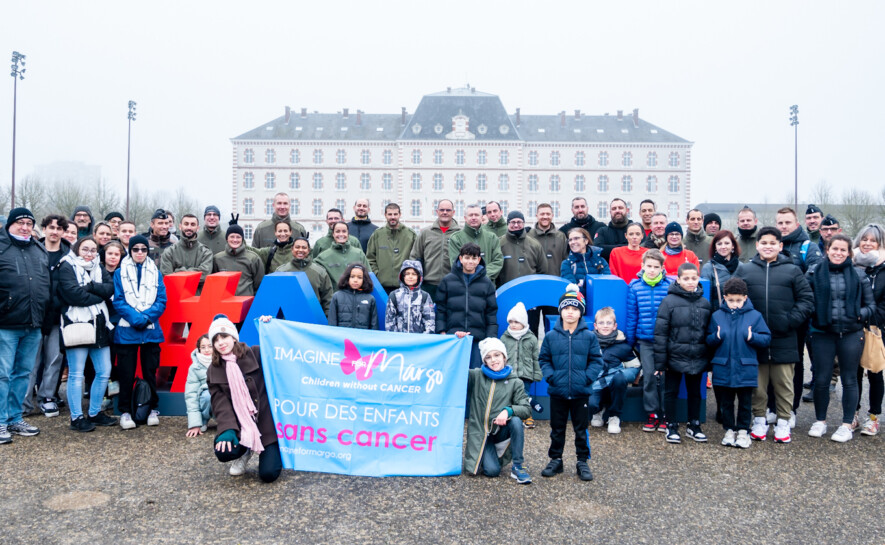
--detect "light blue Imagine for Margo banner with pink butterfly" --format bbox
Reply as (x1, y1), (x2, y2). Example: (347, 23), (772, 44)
(258, 320), (471, 477)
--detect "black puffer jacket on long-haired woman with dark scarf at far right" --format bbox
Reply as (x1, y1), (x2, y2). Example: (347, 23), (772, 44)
(805, 258), (876, 334)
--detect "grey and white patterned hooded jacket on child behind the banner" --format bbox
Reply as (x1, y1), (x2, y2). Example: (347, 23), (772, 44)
(384, 259), (436, 333)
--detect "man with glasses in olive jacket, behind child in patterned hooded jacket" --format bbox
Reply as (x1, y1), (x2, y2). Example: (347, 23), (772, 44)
(409, 199), (461, 302)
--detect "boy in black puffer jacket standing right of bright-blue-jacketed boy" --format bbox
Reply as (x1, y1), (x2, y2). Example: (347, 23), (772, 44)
(655, 263), (712, 443)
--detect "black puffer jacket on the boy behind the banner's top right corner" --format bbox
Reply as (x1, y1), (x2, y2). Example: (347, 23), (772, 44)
(436, 260), (498, 342)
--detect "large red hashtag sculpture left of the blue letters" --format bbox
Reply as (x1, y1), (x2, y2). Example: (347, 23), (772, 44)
(160, 272), (253, 393)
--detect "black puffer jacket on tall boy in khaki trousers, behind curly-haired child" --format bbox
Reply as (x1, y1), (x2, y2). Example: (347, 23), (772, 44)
(735, 254), (814, 364)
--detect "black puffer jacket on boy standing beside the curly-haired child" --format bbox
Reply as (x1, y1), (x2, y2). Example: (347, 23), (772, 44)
(655, 282), (713, 375)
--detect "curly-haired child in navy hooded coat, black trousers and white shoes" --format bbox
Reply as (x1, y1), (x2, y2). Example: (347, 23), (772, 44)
(707, 278), (771, 448)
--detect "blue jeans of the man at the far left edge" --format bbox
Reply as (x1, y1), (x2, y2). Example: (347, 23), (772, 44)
(0, 327), (42, 424)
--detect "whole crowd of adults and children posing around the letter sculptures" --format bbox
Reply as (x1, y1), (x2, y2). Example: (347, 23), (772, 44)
(0, 193), (885, 483)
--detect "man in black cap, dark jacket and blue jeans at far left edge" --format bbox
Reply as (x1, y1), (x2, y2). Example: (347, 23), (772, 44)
(0, 208), (49, 444)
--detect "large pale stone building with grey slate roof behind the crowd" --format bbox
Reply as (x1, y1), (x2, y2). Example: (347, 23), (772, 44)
(231, 88), (693, 237)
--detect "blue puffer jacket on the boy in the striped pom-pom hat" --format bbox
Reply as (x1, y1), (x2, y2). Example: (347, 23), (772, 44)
(538, 318), (602, 399)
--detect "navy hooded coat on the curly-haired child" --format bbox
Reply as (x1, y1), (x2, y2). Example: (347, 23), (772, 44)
(707, 299), (771, 388)
